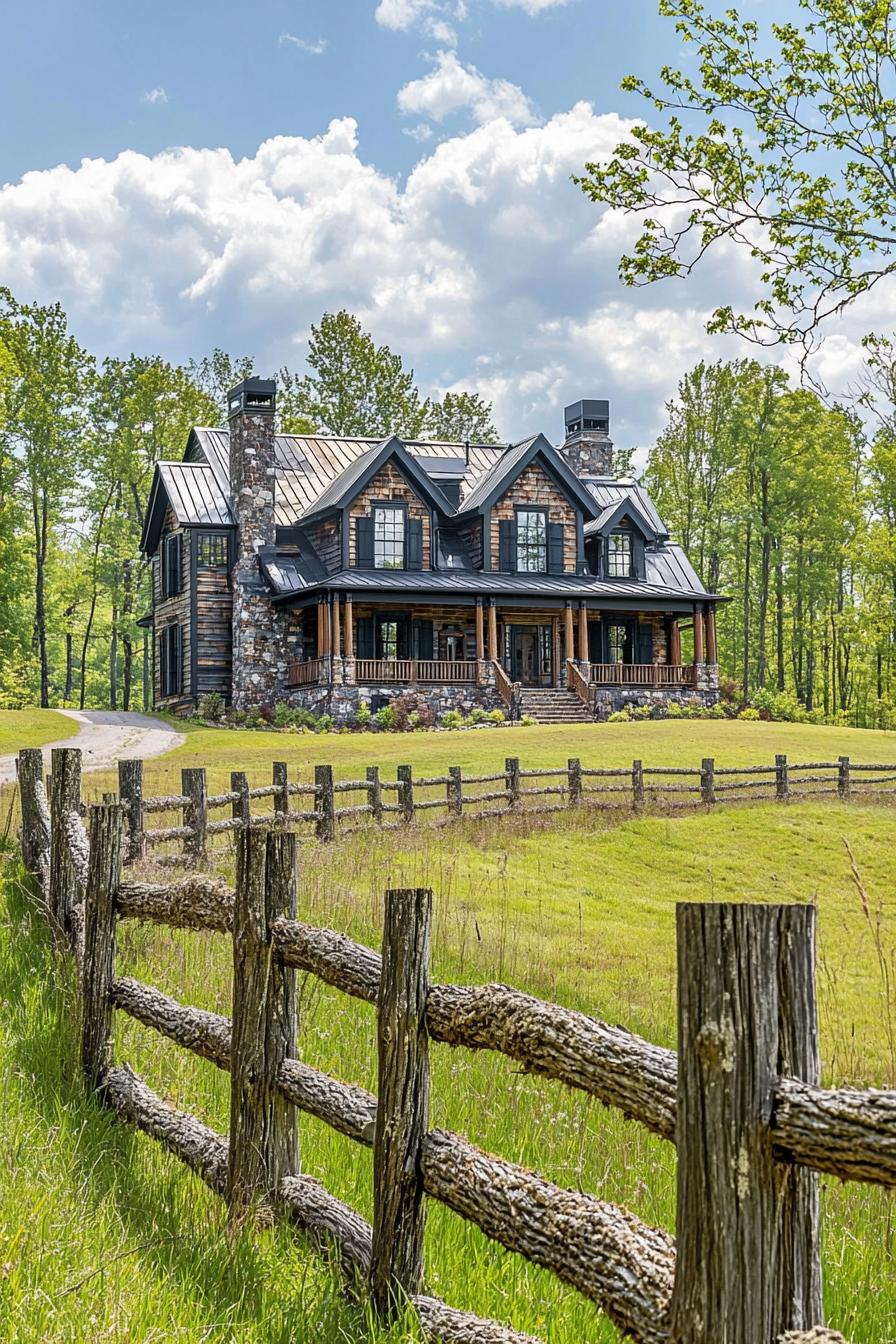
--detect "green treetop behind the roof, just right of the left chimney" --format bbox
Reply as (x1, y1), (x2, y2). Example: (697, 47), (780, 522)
(287, 310), (427, 438)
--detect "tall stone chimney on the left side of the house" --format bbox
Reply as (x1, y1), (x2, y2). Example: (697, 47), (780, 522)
(227, 378), (286, 710)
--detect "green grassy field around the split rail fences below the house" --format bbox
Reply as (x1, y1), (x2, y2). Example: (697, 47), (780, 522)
(0, 723), (896, 1344)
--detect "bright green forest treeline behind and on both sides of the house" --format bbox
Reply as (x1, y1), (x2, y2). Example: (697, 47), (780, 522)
(0, 280), (896, 726)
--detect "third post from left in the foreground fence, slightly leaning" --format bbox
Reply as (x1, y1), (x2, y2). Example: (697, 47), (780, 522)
(81, 802), (122, 1087)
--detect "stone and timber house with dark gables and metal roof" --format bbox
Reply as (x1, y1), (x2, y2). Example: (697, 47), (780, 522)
(141, 379), (723, 722)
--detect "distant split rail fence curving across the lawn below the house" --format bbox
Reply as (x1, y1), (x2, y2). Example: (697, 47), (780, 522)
(15, 749), (896, 866)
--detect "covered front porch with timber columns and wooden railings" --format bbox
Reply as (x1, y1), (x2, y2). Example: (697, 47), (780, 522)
(287, 593), (716, 704)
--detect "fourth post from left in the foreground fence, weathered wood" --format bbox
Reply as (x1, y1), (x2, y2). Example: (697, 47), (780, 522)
(227, 828), (298, 1223)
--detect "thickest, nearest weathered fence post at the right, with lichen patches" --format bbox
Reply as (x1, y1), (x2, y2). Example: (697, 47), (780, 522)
(669, 903), (821, 1344)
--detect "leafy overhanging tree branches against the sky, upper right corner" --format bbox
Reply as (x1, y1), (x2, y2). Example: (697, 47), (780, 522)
(578, 0), (896, 349)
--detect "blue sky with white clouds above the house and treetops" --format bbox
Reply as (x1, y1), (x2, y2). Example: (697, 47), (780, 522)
(0, 0), (860, 448)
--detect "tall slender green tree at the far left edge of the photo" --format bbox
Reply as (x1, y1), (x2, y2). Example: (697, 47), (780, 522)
(0, 289), (93, 708)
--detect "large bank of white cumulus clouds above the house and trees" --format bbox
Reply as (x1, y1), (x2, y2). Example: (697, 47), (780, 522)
(0, 103), (866, 445)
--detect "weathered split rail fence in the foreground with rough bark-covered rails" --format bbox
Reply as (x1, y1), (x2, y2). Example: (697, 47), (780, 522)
(12, 749), (896, 1344)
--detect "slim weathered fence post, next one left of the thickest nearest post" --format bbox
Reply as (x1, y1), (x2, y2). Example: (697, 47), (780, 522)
(369, 887), (433, 1316)
